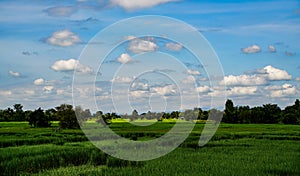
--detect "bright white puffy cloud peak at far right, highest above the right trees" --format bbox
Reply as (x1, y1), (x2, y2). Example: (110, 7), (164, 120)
(264, 65), (292, 80)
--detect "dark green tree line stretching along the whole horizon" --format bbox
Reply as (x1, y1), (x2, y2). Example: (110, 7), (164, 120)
(0, 99), (300, 128)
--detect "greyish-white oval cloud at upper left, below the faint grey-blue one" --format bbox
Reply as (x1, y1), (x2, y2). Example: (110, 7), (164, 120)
(46, 29), (81, 47)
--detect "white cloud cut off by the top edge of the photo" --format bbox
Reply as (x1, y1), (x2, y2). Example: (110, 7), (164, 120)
(110, 0), (178, 10)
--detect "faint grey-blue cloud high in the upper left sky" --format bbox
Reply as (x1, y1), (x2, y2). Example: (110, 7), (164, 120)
(45, 6), (76, 17)
